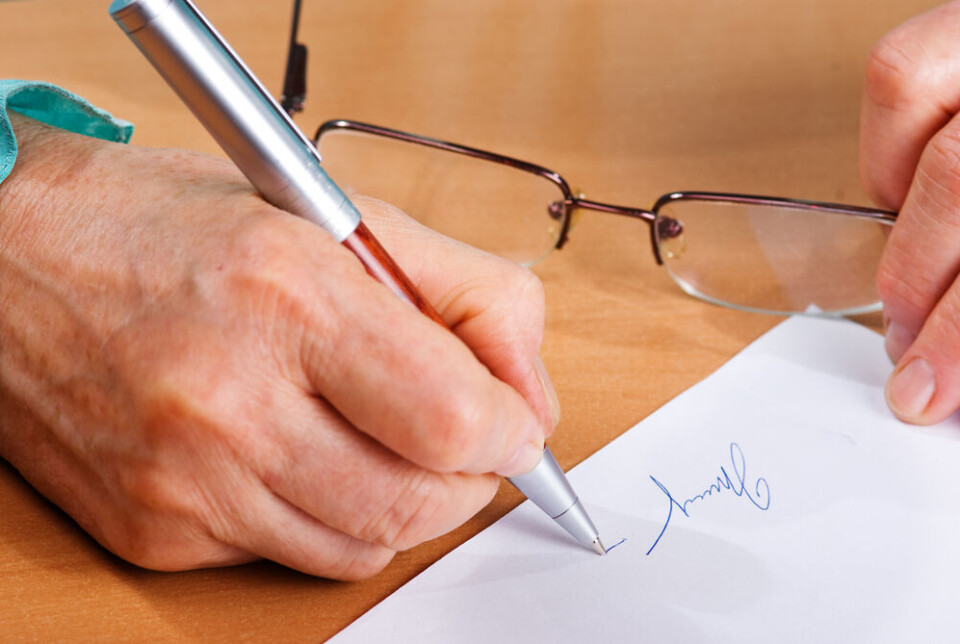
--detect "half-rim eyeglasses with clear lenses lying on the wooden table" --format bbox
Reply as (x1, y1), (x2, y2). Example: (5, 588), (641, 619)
(281, 0), (896, 315)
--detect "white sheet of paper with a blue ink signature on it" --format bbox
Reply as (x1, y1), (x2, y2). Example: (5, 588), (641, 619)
(335, 318), (960, 644)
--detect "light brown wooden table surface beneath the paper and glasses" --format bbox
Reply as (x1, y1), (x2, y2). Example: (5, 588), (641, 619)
(0, 0), (935, 641)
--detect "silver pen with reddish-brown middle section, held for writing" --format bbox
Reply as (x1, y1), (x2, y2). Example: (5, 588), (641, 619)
(110, 0), (605, 555)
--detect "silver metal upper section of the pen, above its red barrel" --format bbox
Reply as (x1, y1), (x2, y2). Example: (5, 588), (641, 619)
(110, 0), (360, 242)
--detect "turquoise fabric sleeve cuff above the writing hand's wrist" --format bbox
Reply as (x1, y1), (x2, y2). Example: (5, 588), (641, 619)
(0, 80), (133, 182)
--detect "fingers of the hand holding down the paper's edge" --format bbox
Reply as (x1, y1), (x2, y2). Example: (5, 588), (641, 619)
(860, 2), (960, 424)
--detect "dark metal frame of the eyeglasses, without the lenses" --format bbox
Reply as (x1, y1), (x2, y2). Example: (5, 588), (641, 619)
(281, 0), (897, 296)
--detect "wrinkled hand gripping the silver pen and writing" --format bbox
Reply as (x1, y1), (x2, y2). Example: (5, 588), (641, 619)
(0, 113), (555, 579)
